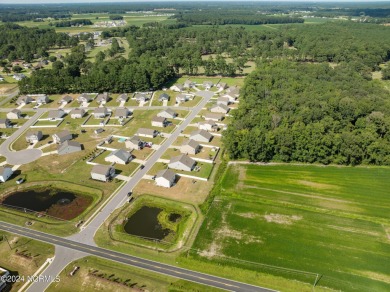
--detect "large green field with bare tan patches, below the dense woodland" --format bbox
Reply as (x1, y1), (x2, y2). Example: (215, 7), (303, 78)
(194, 165), (390, 291)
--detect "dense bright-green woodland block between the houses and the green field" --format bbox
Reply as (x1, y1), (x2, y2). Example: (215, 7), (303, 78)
(224, 61), (390, 165)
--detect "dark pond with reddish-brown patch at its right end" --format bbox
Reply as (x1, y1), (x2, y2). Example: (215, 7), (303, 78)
(1, 189), (92, 220)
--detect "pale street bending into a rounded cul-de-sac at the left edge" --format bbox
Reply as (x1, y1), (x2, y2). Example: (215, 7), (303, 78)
(0, 109), (46, 165)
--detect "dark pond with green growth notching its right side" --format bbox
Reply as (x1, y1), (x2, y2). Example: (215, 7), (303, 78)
(124, 206), (171, 240)
